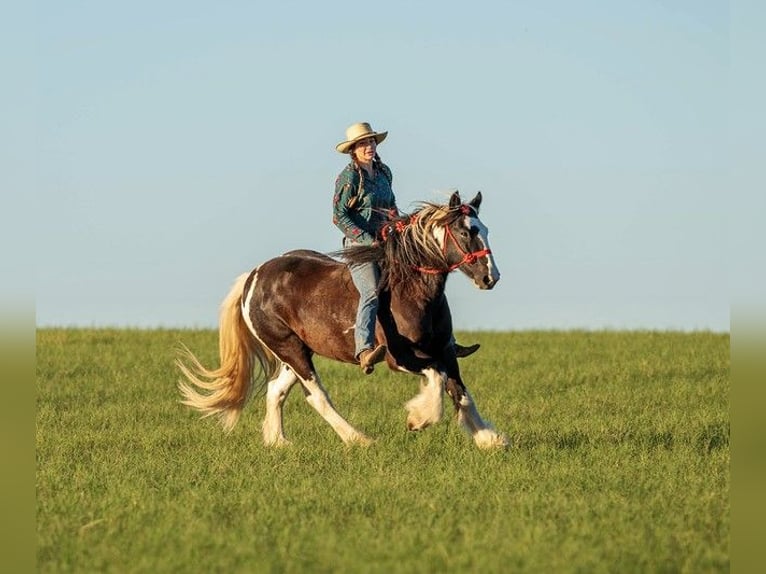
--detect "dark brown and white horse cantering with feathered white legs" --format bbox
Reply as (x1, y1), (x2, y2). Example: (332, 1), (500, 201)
(177, 191), (508, 448)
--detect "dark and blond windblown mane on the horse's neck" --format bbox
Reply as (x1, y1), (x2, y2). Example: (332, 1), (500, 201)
(334, 202), (462, 289)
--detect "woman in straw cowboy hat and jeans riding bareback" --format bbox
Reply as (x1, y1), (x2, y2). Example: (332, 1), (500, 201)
(333, 122), (479, 374)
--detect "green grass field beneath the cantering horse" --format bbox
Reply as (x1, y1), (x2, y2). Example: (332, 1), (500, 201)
(36, 329), (730, 573)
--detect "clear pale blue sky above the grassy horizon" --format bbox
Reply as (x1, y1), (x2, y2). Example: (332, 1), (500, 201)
(13, 0), (756, 331)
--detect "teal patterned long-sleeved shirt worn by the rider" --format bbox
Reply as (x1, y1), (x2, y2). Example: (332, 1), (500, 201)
(332, 163), (398, 245)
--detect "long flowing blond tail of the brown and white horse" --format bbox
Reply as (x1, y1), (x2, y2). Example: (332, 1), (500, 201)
(176, 273), (277, 432)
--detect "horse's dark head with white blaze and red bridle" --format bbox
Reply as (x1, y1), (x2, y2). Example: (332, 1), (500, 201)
(437, 191), (500, 289)
